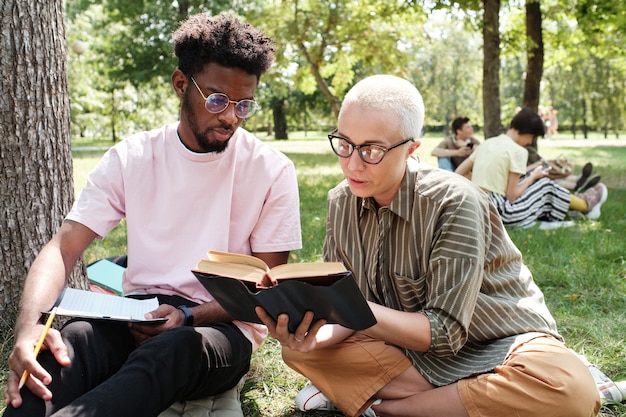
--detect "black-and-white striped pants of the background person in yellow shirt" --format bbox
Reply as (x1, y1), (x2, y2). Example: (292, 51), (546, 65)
(488, 178), (571, 227)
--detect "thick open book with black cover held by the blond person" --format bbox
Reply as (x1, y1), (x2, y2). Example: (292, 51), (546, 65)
(192, 251), (376, 333)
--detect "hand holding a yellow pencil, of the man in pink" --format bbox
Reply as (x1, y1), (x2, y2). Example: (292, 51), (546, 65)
(4, 325), (70, 408)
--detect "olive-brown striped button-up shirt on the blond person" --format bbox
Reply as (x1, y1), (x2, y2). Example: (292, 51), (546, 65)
(324, 159), (561, 386)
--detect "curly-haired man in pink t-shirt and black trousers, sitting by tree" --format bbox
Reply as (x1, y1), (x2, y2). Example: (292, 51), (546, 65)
(4, 14), (301, 417)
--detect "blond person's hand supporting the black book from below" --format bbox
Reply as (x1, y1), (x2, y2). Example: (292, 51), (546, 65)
(255, 307), (326, 352)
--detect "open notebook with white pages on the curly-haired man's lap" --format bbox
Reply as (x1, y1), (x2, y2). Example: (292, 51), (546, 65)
(48, 288), (167, 323)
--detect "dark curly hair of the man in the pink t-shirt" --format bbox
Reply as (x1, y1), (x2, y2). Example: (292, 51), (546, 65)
(172, 13), (274, 79)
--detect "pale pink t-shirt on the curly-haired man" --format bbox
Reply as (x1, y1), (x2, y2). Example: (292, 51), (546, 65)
(67, 123), (302, 348)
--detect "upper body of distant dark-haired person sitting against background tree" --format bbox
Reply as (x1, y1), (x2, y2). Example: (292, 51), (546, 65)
(430, 117), (480, 171)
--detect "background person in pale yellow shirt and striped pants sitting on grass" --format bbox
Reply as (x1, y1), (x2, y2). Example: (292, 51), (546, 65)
(455, 108), (608, 227)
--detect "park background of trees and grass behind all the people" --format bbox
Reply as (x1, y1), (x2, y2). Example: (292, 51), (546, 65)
(0, 0), (626, 417)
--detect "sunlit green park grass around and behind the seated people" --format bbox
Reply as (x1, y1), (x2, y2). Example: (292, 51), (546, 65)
(0, 132), (626, 417)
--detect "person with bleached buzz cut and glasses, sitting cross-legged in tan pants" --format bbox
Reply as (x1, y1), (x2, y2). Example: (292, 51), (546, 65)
(257, 75), (600, 417)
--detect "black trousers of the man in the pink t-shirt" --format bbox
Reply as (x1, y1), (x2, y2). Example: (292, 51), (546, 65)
(4, 297), (252, 417)
